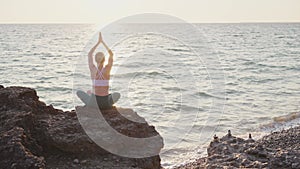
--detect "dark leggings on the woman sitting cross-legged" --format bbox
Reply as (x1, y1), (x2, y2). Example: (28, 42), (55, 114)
(76, 90), (121, 109)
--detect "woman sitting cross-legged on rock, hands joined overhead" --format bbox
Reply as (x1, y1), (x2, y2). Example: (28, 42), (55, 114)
(77, 32), (120, 109)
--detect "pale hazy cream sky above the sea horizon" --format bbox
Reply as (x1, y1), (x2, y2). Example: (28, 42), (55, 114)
(0, 0), (300, 24)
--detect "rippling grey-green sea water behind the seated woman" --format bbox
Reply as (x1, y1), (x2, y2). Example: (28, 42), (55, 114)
(0, 23), (300, 168)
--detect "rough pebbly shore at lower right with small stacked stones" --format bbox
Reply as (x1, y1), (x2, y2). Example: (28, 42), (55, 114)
(176, 126), (300, 169)
